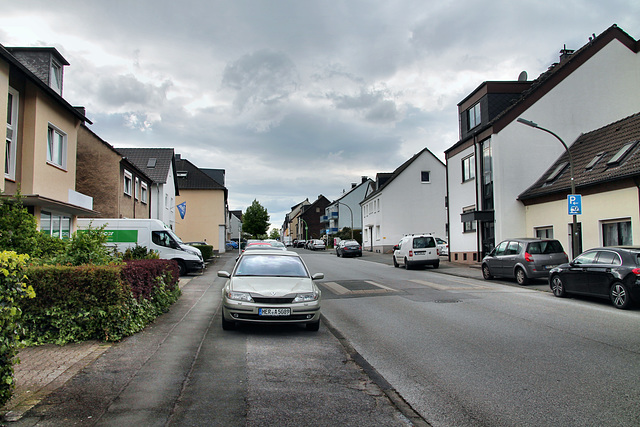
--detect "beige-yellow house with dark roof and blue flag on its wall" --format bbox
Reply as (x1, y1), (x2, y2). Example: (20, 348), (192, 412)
(175, 154), (227, 253)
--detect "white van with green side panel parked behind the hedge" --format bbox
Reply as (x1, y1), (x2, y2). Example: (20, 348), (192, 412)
(78, 218), (204, 276)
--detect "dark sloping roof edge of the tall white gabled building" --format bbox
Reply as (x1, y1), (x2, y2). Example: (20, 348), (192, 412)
(445, 24), (640, 154)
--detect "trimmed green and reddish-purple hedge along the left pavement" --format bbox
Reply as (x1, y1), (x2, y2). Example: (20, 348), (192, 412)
(20, 260), (180, 345)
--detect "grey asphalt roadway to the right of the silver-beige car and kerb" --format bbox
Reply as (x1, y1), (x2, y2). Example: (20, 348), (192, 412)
(302, 252), (640, 426)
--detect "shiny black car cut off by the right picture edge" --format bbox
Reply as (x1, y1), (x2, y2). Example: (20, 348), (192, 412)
(549, 247), (640, 308)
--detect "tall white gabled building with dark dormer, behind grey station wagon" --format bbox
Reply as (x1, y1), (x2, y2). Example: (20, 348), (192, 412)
(445, 25), (640, 263)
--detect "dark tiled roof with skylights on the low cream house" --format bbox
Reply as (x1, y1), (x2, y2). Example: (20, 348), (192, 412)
(518, 113), (640, 200)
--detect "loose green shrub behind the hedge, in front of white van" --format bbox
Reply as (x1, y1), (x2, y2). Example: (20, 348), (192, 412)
(54, 225), (118, 266)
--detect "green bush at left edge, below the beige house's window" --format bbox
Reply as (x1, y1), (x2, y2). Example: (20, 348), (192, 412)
(0, 193), (39, 256)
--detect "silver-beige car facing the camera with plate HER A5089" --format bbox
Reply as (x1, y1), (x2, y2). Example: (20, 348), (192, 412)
(218, 250), (324, 331)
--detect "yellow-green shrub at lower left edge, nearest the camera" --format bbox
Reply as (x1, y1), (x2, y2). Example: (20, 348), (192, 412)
(0, 251), (35, 406)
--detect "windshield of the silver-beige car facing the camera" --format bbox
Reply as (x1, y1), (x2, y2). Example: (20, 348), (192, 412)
(235, 254), (309, 277)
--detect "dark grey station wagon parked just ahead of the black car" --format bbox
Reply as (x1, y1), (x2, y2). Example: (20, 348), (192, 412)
(482, 238), (569, 285)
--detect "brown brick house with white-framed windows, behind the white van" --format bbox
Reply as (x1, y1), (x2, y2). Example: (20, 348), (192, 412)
(76, 124), (153, 218)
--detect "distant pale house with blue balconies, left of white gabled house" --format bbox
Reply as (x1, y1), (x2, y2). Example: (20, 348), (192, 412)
(321, 176), (373, 239)
